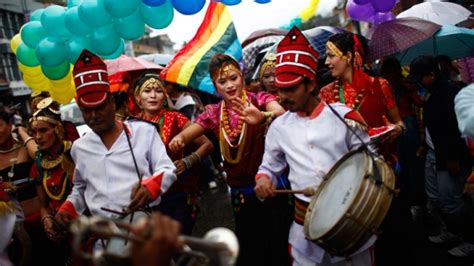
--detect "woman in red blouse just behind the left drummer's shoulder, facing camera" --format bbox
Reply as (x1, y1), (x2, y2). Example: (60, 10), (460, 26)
(135, 74), (213, 234)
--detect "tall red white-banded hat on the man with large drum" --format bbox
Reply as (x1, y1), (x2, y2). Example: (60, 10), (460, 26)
(275, 27), (319, 88)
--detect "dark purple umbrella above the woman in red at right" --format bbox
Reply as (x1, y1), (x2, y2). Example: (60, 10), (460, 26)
(366, 18), (441, 62)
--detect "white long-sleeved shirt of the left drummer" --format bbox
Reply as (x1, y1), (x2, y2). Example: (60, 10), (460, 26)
(67, 121), (176, 218)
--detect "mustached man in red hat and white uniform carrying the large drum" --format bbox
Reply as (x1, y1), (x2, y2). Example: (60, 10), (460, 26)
(255, 28), (375, 265)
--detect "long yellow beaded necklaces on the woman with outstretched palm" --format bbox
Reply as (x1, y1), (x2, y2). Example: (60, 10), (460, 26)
(219, 91), (247, 164)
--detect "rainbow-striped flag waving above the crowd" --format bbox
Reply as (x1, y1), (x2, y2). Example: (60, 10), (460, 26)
(161, 1), (242, 94)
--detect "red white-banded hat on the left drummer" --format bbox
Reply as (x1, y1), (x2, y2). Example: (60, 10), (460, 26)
(72, 50), (109, 108)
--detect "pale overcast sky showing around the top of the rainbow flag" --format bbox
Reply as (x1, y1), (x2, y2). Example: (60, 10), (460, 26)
(152, 0), (337, 48)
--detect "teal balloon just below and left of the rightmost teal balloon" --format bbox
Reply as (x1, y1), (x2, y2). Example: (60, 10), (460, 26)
(115, 9), (145, 40)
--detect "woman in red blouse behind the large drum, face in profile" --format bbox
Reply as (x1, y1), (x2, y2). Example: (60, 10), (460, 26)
(319, 32), (405, 145)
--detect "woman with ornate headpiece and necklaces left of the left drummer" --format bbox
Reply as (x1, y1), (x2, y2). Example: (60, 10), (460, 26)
(30, 97), (75, 263)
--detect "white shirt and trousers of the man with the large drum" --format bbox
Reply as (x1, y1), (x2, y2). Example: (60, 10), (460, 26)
(258, 102), (376, 263)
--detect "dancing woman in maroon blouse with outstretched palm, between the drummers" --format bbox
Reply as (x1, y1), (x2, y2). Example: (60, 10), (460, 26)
(169, 54), (288, 265)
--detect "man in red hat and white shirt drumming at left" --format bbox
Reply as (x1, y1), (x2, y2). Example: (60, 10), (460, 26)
(55, 50), (176, 251)
